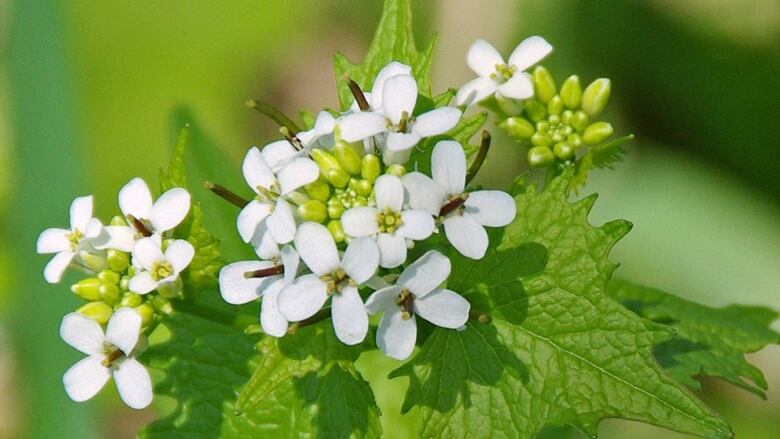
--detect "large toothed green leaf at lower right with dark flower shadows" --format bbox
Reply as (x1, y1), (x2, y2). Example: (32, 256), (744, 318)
(392, 170), (732, 438)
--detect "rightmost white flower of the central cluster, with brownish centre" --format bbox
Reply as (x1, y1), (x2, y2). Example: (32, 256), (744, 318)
(402, 140), (517, 259)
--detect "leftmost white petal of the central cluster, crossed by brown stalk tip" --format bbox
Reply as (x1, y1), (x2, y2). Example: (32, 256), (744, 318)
(219, 261), (279, 305)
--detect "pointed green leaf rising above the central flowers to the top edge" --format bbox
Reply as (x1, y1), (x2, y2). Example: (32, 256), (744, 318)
(333, 0), (436, 110)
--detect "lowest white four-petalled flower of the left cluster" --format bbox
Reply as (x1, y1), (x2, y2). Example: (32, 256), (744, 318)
(60, 308), (152, 409)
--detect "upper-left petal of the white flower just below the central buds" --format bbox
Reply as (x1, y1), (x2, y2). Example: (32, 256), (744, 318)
(295, 222), (339, 276)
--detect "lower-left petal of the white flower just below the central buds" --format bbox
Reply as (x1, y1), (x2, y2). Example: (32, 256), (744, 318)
(276, 274), (328, 322)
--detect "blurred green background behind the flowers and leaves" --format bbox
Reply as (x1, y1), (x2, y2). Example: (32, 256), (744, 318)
(0, 0), (780, 439)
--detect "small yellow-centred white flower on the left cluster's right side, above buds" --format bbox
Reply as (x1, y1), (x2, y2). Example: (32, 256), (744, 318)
(128, 238), (195, 294)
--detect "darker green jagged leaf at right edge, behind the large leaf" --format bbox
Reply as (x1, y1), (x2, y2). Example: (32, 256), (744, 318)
(609, 280), (780, 399)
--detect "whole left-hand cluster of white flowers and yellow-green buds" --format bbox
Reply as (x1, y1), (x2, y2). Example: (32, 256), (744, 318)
(37, 178), (195, 408)
